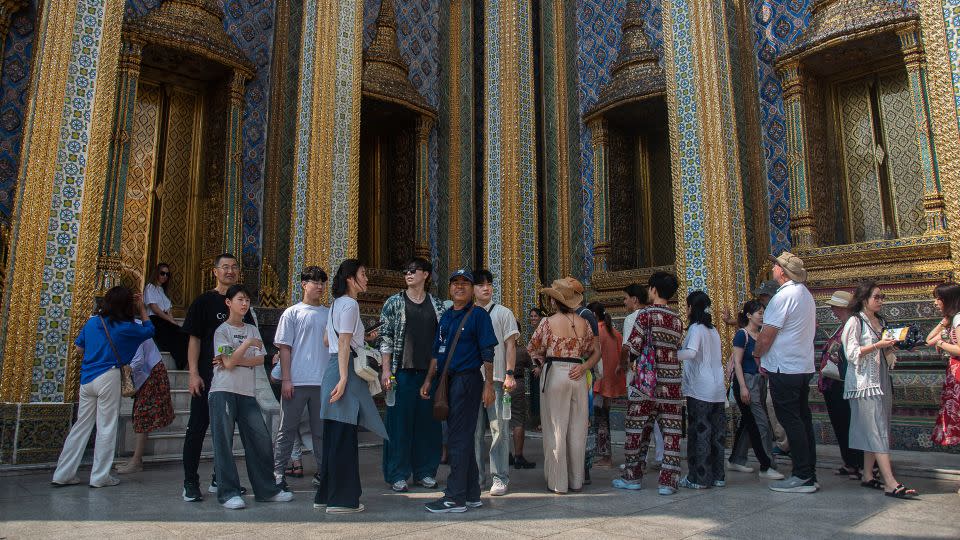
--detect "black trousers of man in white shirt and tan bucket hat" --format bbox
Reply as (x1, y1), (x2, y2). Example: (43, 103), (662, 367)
(768, 373), (817, 480)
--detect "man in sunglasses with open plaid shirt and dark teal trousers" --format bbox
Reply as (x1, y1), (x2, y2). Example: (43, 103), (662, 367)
(380, 257), (444, 492)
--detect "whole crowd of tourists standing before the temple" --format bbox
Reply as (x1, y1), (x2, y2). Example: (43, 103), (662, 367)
(53, 252), (960, 514)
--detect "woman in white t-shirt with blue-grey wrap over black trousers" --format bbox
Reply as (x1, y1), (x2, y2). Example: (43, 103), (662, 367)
(313, 259), (387, 514)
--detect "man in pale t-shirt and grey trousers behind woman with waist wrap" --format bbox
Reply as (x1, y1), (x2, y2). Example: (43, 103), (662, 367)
(273, 266), (330, 491)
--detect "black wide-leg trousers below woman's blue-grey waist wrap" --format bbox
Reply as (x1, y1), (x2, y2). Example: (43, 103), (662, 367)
(313, 420), (361, 508)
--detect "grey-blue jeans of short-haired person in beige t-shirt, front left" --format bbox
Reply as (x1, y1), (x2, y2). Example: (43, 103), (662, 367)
(207, 392), (280, 503)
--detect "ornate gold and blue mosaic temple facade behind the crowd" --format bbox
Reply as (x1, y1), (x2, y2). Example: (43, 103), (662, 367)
(0, 0), (960, 464)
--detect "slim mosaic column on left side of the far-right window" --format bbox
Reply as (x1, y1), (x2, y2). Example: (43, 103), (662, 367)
(780, 62), (817, 247)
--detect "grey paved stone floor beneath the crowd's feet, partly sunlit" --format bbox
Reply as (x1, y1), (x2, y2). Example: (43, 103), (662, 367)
(0, 440), (960, 540)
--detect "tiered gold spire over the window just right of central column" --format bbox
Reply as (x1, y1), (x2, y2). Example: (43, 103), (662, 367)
(587, 0), (667, 121)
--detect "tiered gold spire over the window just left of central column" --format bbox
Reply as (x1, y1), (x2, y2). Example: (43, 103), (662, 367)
(363, 0), (437, 118)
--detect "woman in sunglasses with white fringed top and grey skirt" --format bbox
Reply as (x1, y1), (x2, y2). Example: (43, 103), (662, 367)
(841, 280), (917, 499)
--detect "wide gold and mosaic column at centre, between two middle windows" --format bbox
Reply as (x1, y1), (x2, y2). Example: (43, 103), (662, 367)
(483, 0), (538, 314)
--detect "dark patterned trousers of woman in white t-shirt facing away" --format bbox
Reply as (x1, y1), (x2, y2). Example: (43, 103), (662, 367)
(687, 397), (727, 487)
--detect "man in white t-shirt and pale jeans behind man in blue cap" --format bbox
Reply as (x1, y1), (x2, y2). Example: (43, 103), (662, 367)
(473, 270), (520, 495)
